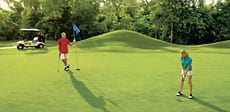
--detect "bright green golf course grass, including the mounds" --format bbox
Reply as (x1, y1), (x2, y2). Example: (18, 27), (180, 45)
(0, 31), (230, 112)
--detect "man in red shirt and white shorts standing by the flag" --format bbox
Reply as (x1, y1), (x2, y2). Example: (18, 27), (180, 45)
(57, 32), (73, 71)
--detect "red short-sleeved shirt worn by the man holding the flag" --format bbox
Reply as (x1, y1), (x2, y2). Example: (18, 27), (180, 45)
(57, 38), (70, 54)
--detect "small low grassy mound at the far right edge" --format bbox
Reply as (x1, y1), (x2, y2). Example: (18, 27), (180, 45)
(203, 40), (230, 48)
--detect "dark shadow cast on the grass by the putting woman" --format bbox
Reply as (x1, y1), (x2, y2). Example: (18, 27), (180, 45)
(192, 97), (226, 112)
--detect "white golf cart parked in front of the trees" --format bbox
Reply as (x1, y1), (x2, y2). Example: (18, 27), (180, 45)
(17, 29), (45, 50)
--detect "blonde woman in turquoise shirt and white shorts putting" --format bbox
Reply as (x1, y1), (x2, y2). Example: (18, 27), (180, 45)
(176, 50), (192, 99)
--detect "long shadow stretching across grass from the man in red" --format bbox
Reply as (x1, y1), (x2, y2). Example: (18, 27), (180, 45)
(67, 71), (110, 112)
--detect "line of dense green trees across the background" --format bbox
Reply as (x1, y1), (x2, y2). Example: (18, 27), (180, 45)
(0, 0), (230, 44)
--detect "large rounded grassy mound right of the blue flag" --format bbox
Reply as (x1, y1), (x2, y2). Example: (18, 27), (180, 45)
(78, 30), (173, 49)
